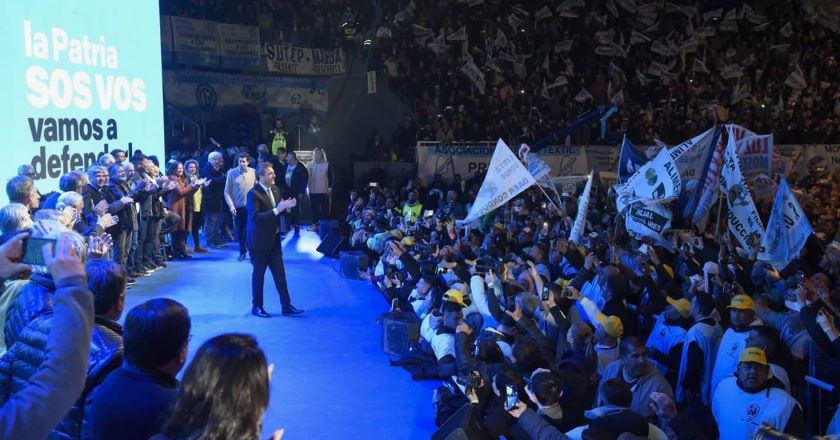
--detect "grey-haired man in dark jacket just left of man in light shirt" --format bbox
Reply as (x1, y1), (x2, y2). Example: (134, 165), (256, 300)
(199, 151), (228, 248)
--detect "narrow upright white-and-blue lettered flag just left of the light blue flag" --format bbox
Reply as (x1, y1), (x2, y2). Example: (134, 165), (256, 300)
(721, 126), (764, 250)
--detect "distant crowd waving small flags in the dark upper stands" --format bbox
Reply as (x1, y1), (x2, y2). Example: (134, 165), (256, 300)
(360, 0), (840, 160)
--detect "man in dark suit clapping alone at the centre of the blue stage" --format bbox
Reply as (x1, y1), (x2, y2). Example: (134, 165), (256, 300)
(245, 163), (303, 318)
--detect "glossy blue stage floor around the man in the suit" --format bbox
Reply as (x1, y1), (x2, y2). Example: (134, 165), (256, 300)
(126, 232), (438, 440)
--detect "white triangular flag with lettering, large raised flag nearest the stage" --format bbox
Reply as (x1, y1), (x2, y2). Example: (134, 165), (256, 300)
(459, 139), (536, 224)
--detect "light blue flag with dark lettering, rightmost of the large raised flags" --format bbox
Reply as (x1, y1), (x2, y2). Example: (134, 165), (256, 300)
(758, 179), (814, 270)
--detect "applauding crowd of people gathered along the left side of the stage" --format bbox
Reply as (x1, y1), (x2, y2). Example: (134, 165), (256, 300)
(0, 145), (333, 440)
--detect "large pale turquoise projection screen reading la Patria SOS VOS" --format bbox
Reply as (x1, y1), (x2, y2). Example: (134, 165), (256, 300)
(0, 0), (164, 200)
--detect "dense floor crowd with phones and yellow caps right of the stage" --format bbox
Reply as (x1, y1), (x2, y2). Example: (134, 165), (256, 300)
(344, 150), (840, 439)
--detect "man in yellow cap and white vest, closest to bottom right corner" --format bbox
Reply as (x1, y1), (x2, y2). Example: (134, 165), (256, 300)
(712, 347), (805, 439)
